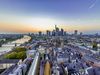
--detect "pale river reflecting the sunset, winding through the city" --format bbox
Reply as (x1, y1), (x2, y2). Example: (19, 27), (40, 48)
(0, 35), (31, 55)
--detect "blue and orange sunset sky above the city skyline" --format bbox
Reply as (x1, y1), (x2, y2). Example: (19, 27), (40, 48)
(0, 0), (100, 33)
